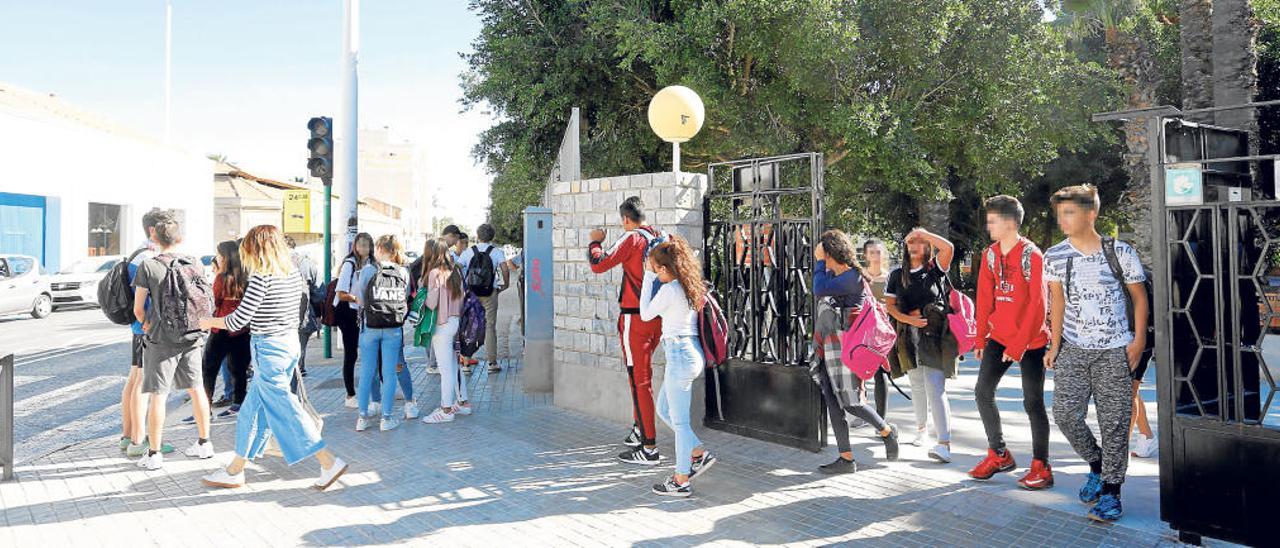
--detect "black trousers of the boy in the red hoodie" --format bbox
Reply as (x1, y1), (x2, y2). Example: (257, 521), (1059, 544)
(974, 341), (1048, 462)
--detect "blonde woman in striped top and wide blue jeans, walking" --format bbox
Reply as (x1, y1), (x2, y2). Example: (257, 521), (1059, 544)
(200, 224), (347, 490)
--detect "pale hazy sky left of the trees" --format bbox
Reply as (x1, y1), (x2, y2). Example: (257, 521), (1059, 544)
(0, 0), (492, 227)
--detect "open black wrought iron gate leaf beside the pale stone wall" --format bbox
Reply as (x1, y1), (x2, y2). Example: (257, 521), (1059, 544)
(703, 154), (827, 451)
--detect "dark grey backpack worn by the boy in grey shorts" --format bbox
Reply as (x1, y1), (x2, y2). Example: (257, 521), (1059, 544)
(147, 254), (214, 344)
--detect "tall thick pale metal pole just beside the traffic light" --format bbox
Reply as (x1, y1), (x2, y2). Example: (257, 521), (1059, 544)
(334, 0), (360, 248)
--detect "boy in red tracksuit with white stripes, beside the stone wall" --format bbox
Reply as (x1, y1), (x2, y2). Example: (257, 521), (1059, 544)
(588, 196), (662, 465)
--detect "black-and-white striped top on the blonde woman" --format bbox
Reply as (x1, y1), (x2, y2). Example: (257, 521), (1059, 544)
(227, 271), (307, 335)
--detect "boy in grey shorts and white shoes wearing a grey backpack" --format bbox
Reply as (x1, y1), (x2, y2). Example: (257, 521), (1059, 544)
(133, 210), (214, 470)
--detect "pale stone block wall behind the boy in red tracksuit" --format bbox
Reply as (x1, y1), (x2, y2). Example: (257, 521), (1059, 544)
(549, 173), (707, 432)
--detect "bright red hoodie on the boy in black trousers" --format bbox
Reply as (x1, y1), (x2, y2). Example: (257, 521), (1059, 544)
(974, 238), (1050, 361)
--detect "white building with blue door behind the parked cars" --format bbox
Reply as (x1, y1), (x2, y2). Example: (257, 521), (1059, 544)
(0, 83), (214, 270)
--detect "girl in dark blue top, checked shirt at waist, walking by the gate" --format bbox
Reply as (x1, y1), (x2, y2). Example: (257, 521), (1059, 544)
(809, 230), (899, 474)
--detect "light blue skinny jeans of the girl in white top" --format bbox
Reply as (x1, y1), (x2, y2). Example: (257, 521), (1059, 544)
(658, 335), (705, 475)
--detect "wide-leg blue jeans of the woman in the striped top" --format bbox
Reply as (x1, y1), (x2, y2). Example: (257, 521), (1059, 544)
(236, 332), (325, 465)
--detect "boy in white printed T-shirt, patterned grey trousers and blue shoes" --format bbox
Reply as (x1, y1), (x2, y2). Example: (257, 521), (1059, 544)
(1044, 184), (1148, 521)
